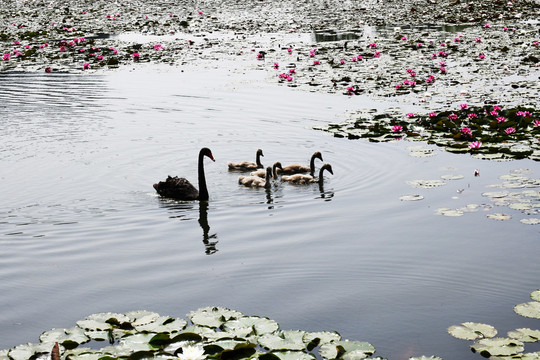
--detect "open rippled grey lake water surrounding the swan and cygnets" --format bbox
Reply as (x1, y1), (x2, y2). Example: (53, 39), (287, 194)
(0, 65), (540, 359)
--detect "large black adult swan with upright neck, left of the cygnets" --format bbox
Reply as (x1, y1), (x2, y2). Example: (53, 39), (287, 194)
(154, 148), (216, 200)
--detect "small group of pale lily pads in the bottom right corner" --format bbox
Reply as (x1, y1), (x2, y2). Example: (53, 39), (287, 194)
(448, 290), (540, 360)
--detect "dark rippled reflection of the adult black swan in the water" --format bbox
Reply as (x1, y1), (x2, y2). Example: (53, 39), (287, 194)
(159, 198), (218, 255)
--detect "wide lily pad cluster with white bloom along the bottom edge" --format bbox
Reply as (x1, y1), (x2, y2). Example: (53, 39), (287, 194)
(0, 307), (388, 360)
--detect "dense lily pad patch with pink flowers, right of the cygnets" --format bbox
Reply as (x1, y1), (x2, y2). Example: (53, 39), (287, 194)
(317, 104), (540, 160)
